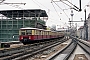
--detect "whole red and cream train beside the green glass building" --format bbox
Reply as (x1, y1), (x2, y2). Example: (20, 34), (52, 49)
(19, 27), (64, 44)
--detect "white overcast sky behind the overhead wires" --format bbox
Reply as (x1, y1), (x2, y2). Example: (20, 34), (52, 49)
(0, 0), (90, 27)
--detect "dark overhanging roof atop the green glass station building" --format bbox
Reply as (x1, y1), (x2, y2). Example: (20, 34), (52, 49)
(0, 9), (48, 18)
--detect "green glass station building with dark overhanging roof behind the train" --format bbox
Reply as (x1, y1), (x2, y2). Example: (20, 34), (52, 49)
(0, 9), (48, 42)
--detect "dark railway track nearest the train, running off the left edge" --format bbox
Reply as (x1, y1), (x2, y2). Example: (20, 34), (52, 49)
(0, 41), (60, 58)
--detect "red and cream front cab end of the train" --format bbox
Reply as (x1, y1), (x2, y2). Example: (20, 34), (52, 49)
(19, 27), (37, 44)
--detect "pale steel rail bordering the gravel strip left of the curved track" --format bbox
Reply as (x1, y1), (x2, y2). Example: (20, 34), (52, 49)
(11, 38), (64, 60)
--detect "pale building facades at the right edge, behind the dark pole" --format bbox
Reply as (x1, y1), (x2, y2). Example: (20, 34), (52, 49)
(77, 14), (90, 40)
